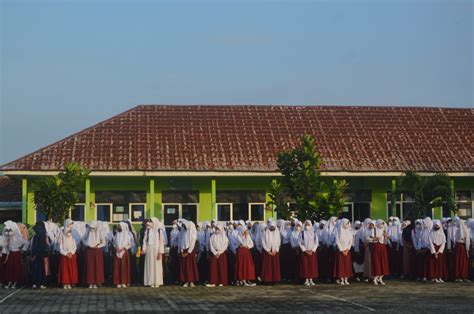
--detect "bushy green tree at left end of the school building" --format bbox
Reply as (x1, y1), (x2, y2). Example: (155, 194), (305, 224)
(34, 163), (90, 222)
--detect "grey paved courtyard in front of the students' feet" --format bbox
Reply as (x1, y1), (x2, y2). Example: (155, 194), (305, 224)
(0, 280), (474, 313)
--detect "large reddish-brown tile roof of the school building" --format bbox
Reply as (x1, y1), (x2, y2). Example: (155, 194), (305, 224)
(1, 105), (474, 172)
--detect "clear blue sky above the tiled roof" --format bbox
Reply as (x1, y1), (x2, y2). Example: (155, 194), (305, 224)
(0, 0), (474, 163)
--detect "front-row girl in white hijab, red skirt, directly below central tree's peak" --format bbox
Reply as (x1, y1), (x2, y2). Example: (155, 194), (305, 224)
(298, 220), (319, 286)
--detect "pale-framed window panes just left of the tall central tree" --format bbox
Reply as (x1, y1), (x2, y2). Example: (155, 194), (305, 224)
(217, 203), (265, 221)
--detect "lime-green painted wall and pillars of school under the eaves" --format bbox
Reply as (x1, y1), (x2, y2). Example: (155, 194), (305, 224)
(22, 177), (474, 224)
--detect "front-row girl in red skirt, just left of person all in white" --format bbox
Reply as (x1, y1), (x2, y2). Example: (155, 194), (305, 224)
(113, 222), (132, 288)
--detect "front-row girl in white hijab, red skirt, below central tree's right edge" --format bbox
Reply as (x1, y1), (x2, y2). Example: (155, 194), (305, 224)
(333, 218), (354, 285)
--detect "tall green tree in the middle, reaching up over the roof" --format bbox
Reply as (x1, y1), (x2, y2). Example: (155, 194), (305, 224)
(270, 135), (348, 220)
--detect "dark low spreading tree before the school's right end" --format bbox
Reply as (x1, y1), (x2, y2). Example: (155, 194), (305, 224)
(397, 171), (456, 219)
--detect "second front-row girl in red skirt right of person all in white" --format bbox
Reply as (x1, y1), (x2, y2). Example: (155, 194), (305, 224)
(206, 224), (229, 287)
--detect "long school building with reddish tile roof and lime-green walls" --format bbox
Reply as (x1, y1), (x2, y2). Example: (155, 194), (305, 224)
(0, 105), (474, 226)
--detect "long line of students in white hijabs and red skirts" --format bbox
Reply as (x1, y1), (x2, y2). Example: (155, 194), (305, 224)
(0, 217), (474, 289)
